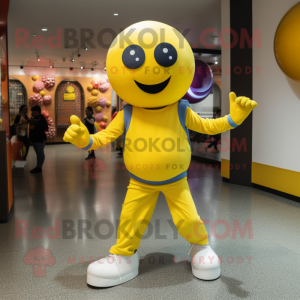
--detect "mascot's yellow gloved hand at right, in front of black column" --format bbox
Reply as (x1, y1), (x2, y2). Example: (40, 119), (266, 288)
(228, 92), (257, 127)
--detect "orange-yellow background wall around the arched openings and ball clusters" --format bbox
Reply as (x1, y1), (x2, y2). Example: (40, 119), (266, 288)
(12, 75), (112, 143)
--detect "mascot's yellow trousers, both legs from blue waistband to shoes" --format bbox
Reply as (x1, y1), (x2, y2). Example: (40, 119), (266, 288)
(110, 178), (208, 256)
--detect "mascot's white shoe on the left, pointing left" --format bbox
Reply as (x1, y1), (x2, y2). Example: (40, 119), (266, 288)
(87, 252), (139, 287)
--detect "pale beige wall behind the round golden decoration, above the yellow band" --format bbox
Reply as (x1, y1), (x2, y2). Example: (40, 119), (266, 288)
(253, 0), (300, 172)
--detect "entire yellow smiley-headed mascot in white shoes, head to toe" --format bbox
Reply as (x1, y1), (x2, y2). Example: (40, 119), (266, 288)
(64, 21), (257, 287)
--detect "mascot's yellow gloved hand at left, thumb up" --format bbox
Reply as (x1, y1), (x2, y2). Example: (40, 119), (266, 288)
(63, 115), (92, 150)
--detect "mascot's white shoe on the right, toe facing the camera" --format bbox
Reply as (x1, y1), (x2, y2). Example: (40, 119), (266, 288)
(190, 244), (221, 280)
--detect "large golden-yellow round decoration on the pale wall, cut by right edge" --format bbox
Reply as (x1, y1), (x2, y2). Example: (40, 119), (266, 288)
(274, 2), (300, 83)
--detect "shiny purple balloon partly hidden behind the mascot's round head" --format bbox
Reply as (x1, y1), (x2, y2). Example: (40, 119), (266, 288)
(182, 60), (213, 103)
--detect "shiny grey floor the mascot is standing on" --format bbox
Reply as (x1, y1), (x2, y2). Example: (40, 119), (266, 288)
(0, 145), (300, 300)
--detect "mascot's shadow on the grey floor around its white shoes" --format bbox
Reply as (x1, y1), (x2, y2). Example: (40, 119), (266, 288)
(55, 253), (245, 298)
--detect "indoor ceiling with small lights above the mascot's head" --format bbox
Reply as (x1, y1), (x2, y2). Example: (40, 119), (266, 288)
(8, 0), (221, 70)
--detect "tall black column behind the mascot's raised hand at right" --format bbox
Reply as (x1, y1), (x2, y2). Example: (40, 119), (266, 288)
(230, 0), (253, 186)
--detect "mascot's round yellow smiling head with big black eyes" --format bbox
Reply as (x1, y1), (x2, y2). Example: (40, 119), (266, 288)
(106, 21), (195, 108)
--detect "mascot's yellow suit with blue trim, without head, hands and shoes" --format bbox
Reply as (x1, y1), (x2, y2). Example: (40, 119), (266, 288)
(89, 100), (233, 256)
